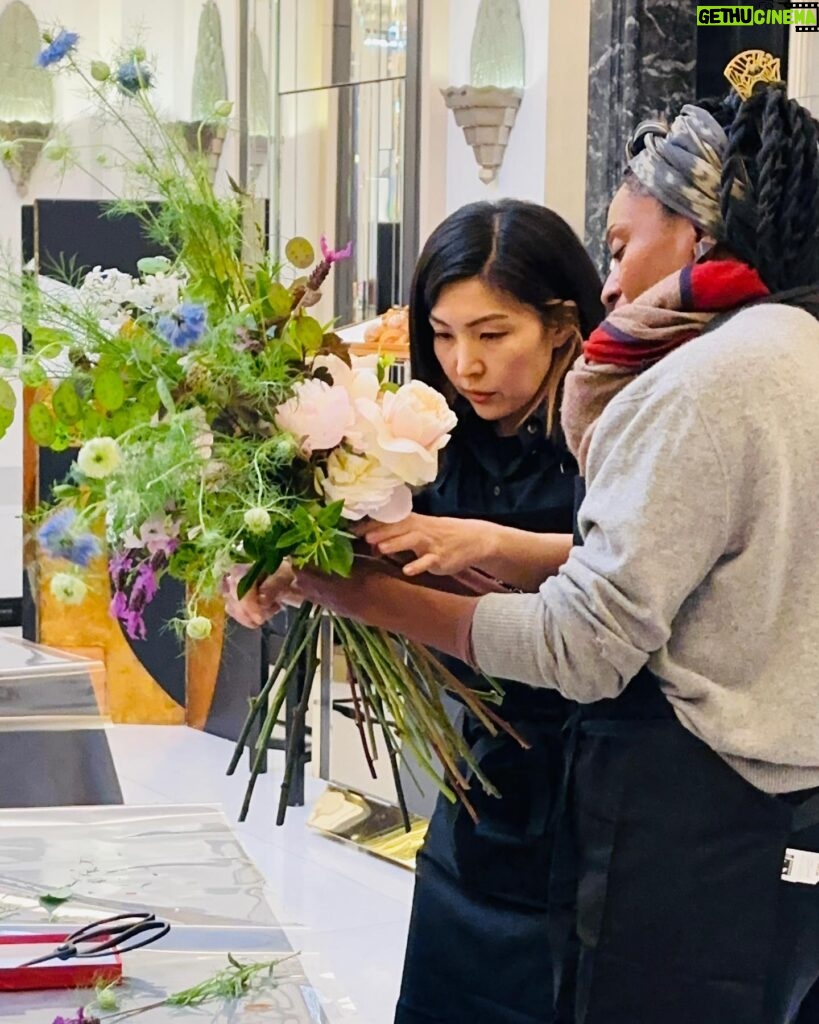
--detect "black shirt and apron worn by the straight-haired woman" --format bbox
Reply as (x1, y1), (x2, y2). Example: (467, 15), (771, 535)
(395, 407), (574, 1024)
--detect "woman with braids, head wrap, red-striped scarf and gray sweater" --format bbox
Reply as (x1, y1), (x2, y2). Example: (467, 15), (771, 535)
(288, 67), (819, 1024)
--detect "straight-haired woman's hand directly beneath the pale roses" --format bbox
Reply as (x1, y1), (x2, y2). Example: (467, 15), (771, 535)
(356, 512), (495, 577)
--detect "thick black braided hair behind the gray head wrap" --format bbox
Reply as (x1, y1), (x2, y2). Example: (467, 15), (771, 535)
(716, 83), (819, 292)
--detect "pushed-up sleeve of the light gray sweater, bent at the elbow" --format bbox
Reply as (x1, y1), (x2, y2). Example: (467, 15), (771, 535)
(471, 382), (730, 702)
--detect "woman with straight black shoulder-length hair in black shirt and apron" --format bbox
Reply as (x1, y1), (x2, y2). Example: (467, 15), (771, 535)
(384, 200), (603, 1024)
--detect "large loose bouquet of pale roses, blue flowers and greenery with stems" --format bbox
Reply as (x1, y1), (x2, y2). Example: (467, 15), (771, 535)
(0, 31), (518, 820)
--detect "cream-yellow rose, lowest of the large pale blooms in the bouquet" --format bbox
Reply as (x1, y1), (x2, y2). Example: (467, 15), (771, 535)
(315, 449), (413, 522)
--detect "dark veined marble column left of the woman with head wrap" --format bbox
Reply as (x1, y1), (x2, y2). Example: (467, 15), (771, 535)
(586, 0), (696, 273)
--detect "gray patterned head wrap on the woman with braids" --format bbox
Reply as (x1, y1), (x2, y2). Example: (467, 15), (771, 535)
(629, 103), (743, 240)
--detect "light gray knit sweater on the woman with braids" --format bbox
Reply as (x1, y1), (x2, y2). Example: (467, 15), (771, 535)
(472, 305), (819, 793)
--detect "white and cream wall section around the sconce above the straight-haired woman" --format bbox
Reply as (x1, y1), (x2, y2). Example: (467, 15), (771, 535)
(420, 0), (591, 242)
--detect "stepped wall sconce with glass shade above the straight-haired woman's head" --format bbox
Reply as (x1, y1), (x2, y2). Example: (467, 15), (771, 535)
(441, 0), (525, 184)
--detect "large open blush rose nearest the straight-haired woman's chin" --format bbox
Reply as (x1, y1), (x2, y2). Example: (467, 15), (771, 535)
(355, 381), (458, 486)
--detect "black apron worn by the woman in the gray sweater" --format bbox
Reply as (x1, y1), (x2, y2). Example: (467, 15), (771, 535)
(550, 483), (819, 1024)
